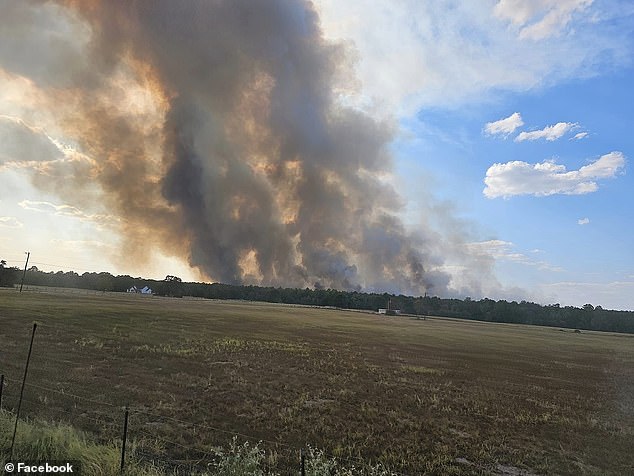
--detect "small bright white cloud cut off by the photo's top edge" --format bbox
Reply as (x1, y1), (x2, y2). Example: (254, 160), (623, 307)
(493, 0), (593, 40)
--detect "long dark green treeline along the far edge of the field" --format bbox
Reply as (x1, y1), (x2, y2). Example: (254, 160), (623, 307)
(6, 267), (634, 333)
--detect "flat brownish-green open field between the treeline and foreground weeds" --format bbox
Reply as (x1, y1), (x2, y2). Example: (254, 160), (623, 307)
(0, 290), (634, 475)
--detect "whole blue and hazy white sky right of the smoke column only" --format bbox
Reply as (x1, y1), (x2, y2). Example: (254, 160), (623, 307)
(316, 0), (634, 309)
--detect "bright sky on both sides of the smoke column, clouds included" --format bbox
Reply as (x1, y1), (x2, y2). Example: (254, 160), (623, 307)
(0, 0), (634, 310)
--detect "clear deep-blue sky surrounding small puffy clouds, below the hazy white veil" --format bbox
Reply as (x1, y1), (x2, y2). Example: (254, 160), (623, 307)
(394, 69), (634, 305)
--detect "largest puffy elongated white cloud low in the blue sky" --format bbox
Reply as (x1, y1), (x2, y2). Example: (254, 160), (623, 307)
(483, 152), (625, 198)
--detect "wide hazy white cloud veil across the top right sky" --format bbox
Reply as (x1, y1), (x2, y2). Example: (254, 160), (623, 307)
(315, 0), (632, 115)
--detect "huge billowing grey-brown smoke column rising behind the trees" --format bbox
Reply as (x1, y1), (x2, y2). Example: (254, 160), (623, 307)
(4, 0), (449, 294)
